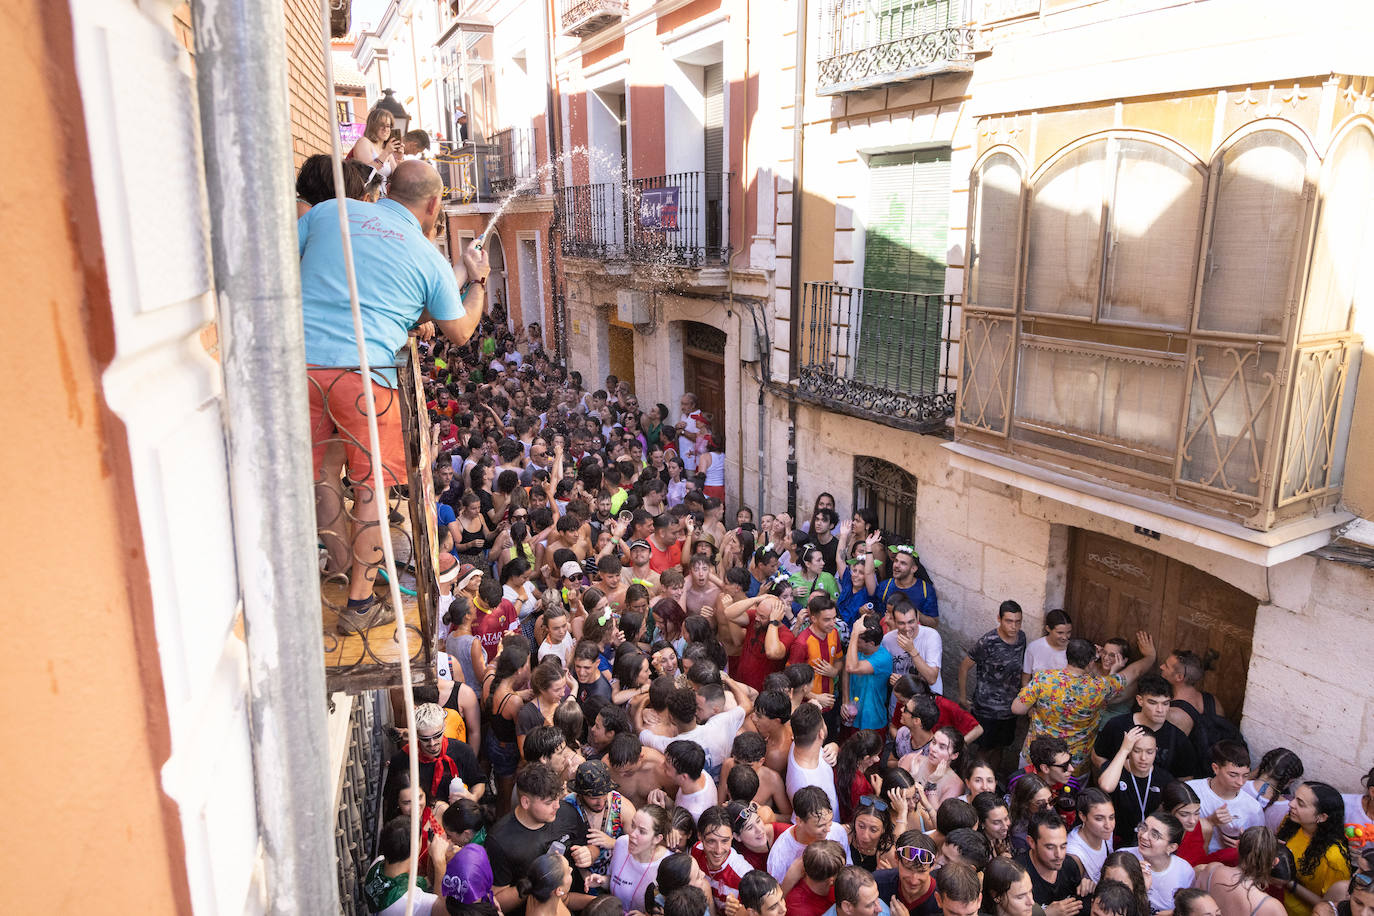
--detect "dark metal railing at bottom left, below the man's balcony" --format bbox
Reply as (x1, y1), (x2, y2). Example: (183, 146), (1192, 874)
(330, 691), (390, 916)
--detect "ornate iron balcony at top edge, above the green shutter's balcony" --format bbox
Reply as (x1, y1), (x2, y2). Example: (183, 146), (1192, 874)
(816, 0), (973, 95)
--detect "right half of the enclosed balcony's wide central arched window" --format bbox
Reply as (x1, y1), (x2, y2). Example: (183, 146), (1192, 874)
(1102, 140), (1205, 330)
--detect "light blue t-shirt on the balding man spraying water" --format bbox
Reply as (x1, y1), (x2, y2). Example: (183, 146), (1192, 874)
(295, 201), (463, 383)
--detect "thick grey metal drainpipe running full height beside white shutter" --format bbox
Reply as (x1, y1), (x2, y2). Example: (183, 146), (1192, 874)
(191, 0), (339, 913)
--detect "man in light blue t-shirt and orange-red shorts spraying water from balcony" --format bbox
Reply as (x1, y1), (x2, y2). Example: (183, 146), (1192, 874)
(297, 161), (491, 634)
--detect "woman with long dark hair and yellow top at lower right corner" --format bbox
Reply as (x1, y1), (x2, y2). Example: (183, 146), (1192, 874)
(1278, 783), (1353, 916)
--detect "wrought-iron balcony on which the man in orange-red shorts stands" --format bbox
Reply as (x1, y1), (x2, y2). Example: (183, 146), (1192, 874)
(312, 341), (438, 694)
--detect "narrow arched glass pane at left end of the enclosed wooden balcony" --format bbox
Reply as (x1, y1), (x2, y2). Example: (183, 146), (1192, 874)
(969, 152), (1021, 309)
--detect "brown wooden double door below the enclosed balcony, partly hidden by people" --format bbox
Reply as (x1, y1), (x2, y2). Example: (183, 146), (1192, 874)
(1066, 530), (1259, 721)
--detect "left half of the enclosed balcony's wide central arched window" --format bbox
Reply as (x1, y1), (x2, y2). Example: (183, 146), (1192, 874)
(1026, 140), (1107, 317)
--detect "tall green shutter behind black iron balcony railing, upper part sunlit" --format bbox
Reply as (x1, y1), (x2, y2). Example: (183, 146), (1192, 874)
(855, 148), (949, 393)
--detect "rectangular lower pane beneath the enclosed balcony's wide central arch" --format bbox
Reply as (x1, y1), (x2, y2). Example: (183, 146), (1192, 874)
(1015, 341), (1184, 456)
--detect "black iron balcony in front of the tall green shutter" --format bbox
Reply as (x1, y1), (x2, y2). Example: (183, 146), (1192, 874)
(798, 283), (959, 433)
